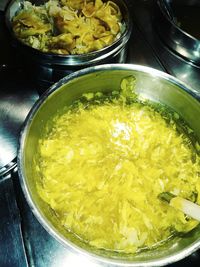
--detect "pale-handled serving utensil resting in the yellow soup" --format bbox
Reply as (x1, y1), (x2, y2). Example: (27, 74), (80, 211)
(158, 192), (200, 221)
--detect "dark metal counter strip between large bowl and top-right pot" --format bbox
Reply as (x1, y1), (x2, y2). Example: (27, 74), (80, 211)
(132, 0), (200, 92)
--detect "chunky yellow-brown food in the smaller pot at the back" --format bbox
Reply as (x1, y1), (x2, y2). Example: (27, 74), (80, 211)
(12, 0), (125, 55)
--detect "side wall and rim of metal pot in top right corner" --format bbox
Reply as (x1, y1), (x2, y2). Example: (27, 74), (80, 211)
(155, 0), (200, 64)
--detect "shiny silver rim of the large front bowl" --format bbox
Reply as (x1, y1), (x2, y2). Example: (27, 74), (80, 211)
(17, 64), (200, 267)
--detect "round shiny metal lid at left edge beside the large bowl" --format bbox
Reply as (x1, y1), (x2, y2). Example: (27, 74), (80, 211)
(0, 65), (38, 176)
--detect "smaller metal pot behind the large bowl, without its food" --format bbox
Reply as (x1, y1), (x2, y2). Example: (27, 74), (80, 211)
(5, 0), (132, 84)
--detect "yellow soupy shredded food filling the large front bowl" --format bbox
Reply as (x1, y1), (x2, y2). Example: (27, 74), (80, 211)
(35, 77), (200, 253)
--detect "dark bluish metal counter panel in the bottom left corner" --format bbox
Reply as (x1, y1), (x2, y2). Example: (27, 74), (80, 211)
(0, 176), (27, 267)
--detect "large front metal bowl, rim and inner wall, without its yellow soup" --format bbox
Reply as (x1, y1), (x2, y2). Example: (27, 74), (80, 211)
(18, 64), (200, 266)
